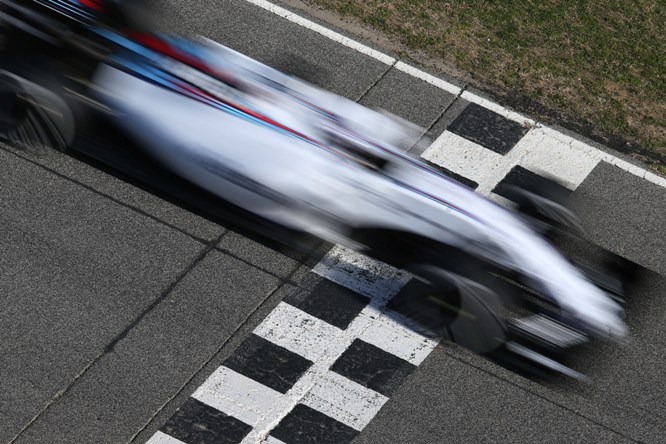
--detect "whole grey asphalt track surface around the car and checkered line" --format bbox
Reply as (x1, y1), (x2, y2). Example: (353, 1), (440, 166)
(0, 0), (666, 443)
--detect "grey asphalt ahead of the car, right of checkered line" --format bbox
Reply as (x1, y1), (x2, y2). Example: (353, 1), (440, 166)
(355, 163), (666, 443)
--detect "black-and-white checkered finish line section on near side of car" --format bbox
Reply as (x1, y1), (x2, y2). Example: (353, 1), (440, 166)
(149, 247), (437, 444)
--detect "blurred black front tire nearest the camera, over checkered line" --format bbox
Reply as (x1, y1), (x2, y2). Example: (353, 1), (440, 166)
(392, 264), (512, 354)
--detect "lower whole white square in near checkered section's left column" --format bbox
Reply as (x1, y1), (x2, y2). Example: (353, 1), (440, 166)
(192, 366), (286, 426)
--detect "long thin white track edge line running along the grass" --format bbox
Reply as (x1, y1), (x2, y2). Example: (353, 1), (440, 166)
(245, 0), (666, 189)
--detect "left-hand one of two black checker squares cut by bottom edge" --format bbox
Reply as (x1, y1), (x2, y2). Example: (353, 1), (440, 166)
(160, 398), (252, 444)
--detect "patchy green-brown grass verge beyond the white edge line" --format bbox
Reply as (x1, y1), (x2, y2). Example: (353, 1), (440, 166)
(305, 0), (666, 168)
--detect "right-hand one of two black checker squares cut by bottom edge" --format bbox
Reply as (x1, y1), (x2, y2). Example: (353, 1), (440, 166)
(271, 404), (359, 444)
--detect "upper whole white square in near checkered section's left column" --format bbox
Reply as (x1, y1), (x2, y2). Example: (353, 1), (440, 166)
(254, 302), (342, 361)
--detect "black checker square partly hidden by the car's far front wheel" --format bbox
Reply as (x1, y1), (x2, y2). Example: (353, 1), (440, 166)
(493, 165), (573, 202)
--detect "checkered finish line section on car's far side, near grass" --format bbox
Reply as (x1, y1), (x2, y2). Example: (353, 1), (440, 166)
(421, 103), (604, 201)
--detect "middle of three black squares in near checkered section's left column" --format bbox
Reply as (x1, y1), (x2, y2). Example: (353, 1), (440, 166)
(224, 334), (312, 393)
